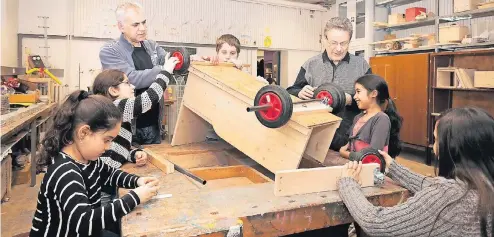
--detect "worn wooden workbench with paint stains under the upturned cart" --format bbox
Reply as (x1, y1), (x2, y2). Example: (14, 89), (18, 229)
(120, 142), (408, 237)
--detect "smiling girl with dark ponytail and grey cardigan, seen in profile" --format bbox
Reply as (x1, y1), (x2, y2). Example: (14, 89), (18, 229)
(340, 74), (403, 158)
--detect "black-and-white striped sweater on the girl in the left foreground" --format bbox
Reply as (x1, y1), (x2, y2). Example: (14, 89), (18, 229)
(30, 152), (140, 237)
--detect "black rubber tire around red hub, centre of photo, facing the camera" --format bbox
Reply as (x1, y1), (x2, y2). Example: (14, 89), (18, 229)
(254, 85), (293, 128)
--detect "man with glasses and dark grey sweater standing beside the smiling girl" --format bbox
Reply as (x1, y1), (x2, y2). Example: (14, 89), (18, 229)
(287, 17), (372, 154)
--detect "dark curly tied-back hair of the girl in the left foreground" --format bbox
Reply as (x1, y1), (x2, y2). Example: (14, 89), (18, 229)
(41, 90), (122, 164)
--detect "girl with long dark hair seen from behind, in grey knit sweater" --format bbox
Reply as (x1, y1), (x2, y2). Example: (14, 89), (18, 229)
(338, 108), (494, 237)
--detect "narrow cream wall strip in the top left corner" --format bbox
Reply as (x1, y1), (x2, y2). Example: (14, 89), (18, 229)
(0, 0), (19, 67)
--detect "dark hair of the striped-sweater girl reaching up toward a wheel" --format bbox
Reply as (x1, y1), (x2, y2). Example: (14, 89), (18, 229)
(93, 69), (125, 100)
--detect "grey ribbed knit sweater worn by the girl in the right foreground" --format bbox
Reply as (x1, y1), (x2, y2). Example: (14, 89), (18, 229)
(338, 162), (492, 237)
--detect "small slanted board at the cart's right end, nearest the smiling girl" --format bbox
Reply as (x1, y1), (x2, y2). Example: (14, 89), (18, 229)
(304, 121), (340, 162)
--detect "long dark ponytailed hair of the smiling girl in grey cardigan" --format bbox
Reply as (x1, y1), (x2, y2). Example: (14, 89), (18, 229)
(355, 74), (403, 157)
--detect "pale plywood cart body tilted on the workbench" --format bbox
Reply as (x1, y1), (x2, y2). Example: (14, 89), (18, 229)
(171, 65), (341, 172)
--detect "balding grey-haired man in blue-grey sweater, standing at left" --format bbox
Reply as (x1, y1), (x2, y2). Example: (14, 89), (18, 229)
(99, 3), (166, 144)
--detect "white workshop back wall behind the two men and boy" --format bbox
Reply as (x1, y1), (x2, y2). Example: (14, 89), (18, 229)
(18, 0), (329, 90)
